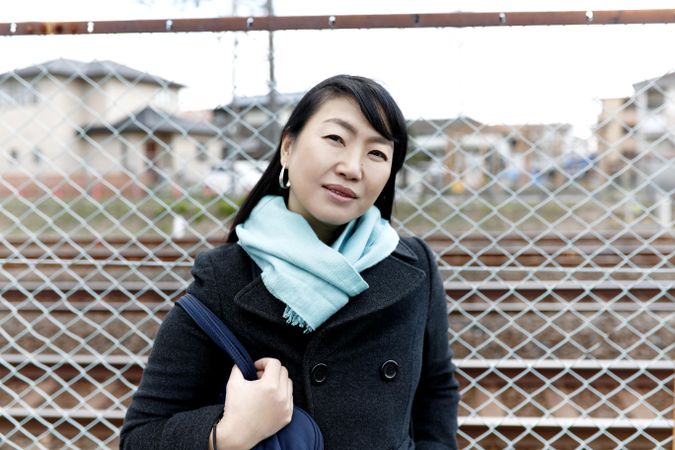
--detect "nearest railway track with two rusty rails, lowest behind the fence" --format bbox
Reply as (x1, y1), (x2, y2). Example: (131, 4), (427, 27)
(0, 354), (674, 448)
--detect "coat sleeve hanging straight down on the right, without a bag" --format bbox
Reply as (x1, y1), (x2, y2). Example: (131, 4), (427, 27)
(412, 239), (459, 450)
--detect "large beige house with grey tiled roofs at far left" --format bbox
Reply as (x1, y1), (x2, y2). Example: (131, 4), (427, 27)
(0, 59), (219, 196)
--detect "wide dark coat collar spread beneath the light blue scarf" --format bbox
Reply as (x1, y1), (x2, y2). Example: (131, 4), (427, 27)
(234, 240), (426, 332)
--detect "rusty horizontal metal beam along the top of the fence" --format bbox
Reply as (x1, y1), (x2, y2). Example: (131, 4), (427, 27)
(0, 9), (675, 36)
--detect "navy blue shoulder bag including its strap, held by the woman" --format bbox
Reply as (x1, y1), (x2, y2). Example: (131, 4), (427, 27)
(177, 294), (323, 450)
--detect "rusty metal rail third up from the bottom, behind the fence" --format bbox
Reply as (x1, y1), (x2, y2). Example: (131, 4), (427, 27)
(0, 280), (675, 312)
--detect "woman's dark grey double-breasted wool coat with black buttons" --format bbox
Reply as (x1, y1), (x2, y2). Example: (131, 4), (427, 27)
(121, 238), (459, 450)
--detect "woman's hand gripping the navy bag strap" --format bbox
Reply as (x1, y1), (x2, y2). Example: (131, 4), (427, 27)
(217, 358), (293, 450)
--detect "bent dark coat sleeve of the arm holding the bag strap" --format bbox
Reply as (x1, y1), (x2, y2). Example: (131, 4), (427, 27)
(120, 254), (232, 450)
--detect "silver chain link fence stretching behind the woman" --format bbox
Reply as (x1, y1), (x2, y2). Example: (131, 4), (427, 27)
(0, 14), (675, 450)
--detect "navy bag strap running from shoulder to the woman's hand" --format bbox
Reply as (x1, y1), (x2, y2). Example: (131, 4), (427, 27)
(176, 294), (258, 381)
